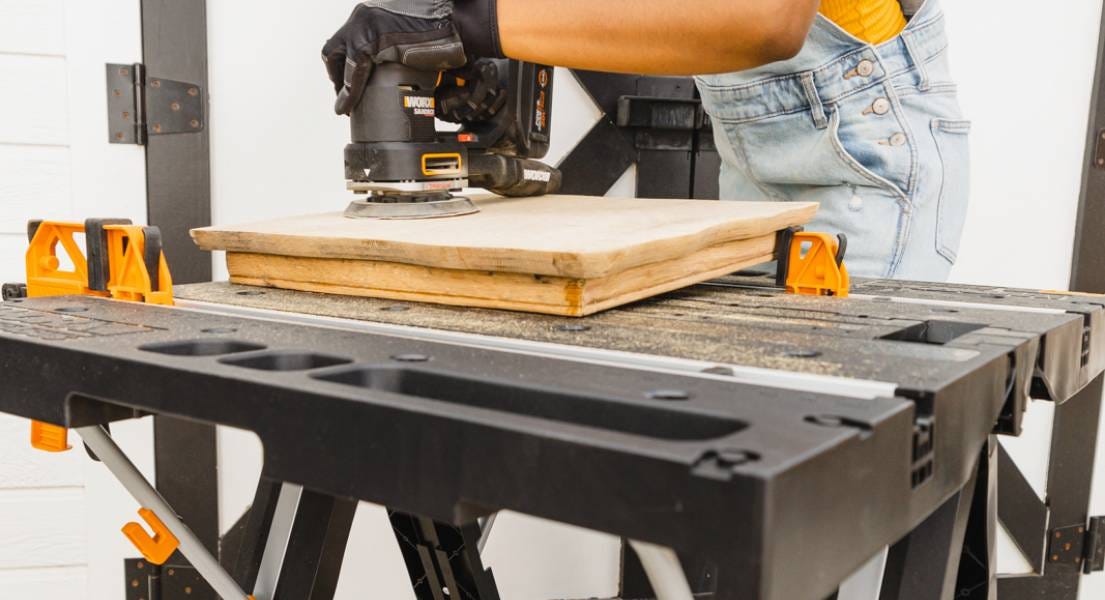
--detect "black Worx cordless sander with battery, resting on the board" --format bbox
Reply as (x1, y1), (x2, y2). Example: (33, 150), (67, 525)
(345, 59), (560, 219)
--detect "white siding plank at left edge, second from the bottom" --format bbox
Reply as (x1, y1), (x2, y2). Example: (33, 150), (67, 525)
(0, 487), (87, 569)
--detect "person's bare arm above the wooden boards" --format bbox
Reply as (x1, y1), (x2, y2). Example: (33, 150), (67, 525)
(498, 0), (820, 75)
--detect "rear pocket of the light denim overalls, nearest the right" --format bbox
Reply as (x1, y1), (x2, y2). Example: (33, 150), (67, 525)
(932, 119), (970, 263)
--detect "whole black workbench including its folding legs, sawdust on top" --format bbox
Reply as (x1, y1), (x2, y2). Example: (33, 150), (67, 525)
(0, 275), (1105, 600)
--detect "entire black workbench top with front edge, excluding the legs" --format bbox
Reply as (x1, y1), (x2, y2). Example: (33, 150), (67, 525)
(0, 280), (1105, 600)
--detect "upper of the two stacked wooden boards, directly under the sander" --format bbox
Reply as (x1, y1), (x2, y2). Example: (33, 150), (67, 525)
(192, 196), (817, 280)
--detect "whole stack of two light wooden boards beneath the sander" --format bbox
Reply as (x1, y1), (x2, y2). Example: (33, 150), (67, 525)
(192, 196), (815, 316)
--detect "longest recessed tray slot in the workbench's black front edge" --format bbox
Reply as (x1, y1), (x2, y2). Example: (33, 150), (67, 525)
(312, 366), (747, 441)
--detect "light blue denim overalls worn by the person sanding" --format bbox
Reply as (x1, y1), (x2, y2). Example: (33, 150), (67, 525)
(696, 0), (970, 281)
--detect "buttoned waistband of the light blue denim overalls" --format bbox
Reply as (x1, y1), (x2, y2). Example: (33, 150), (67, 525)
(698, 11), (948, 122)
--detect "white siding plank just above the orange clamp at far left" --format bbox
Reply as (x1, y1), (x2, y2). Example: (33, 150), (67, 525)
(0, 145), (74, 233)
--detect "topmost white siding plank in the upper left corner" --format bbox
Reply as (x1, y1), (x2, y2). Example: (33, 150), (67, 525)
(0, 0), (65, 56)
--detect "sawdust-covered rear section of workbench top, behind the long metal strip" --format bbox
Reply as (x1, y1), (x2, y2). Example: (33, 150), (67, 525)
(176, 276), (1105, 413)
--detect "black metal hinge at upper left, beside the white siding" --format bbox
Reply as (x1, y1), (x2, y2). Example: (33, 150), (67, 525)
(107, 63), (204, 145)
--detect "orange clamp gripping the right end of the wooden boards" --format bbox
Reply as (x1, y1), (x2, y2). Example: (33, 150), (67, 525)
(787, 231), (850, 297)
